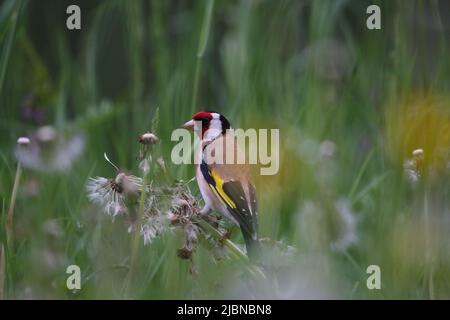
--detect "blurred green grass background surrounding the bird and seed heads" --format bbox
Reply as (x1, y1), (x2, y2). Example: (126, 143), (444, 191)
(0, 0), (450, 299)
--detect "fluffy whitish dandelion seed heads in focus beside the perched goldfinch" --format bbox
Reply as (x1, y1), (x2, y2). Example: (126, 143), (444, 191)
(86, 132), (212, 259)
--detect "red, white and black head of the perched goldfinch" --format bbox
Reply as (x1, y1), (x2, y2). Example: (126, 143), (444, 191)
(183, 111), (230, 139)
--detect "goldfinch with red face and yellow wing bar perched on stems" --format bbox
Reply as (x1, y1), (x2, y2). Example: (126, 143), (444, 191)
(182, 111), (259, 257)
